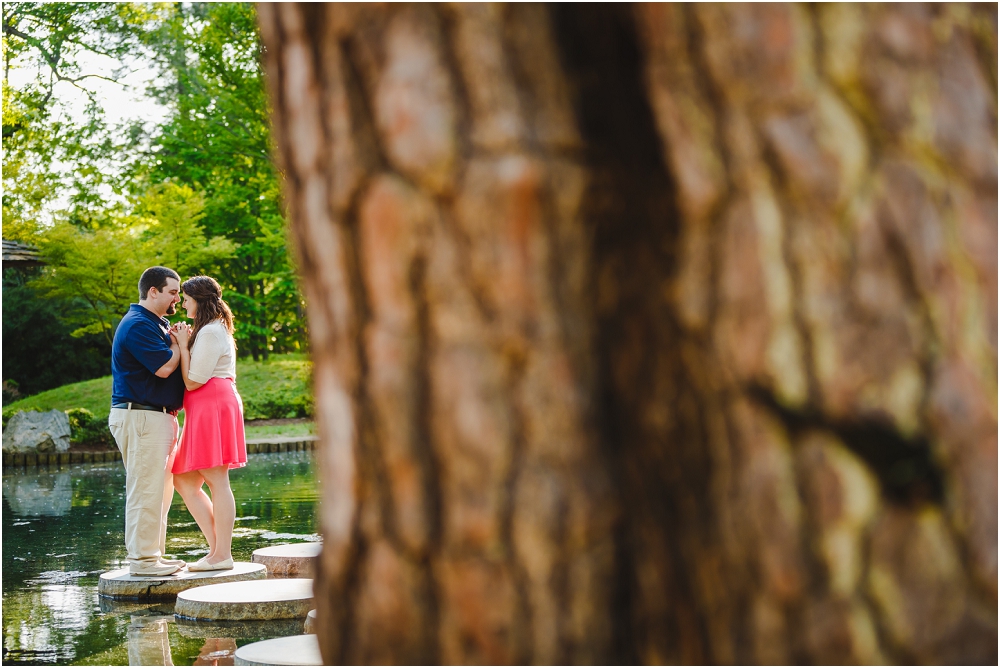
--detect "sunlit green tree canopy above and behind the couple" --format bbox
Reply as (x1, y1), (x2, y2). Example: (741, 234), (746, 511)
(3, 2), (306, 389)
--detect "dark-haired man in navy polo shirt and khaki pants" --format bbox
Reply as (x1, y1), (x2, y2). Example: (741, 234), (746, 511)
(108, 267), (185, 576)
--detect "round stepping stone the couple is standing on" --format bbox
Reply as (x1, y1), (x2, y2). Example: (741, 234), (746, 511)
(97, 561), (267, 601)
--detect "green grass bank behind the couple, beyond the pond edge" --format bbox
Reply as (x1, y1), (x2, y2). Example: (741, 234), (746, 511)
(3, 354), (313, 426)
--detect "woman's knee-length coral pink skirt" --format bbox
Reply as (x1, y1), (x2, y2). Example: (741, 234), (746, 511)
(171, 378), (247, 473)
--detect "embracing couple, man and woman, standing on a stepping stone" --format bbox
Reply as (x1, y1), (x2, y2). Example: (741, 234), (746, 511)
(108, 267), (247, 577)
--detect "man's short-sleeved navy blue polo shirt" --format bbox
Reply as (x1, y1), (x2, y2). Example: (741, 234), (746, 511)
(111, 304), (184, 409)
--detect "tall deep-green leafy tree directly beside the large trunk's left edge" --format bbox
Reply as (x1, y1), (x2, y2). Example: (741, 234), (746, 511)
(140, 3), (306, 359)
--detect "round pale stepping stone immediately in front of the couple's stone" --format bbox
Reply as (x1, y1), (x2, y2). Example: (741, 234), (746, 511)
(174, 576), (313, 620)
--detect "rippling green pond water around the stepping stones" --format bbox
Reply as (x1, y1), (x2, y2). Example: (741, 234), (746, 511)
(3, 452), (319, 666)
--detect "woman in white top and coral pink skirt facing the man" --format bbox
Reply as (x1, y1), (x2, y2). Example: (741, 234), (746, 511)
(171, 276), (247, 571)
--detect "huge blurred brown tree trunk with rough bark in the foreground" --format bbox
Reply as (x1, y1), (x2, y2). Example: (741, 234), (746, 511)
(259, 4), (997, 664)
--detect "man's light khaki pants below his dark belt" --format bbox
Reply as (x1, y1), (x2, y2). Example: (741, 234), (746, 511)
(108, 408), (177, 568)
